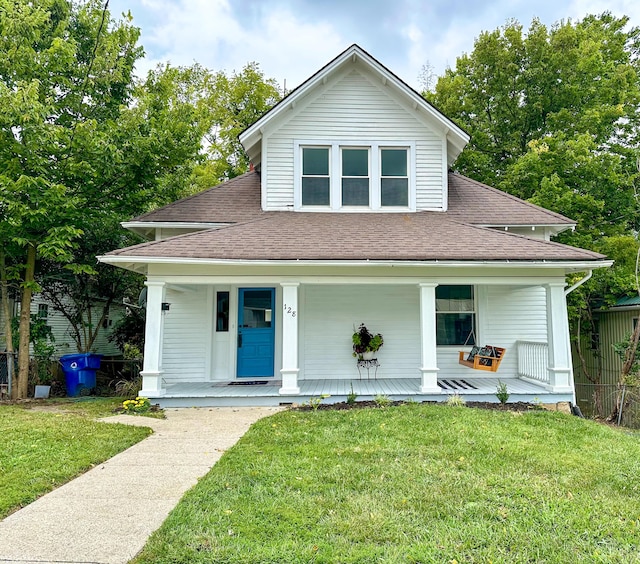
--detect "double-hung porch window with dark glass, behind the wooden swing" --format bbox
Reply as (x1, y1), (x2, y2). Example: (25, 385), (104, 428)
(436, 285), (476, 345)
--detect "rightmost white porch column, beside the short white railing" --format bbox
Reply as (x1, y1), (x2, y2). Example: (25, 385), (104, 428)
(545, 282), (573, 393)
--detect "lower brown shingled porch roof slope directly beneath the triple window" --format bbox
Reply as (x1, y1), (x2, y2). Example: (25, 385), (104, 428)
(108, 212), (604, 261)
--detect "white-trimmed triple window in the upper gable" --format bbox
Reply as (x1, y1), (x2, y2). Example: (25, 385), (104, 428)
(294, 141), (415, 211)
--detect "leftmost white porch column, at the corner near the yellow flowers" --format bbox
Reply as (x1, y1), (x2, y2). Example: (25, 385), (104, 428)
(140, 280), (166, 397)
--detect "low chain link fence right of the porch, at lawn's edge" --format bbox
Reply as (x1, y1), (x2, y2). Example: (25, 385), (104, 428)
(576, 382), (640, 429)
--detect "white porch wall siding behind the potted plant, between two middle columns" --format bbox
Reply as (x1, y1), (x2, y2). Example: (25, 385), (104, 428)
(301, 285), (420, 379)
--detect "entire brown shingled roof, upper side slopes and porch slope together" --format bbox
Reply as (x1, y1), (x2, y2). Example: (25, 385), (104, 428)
(112, 172), (605, 261)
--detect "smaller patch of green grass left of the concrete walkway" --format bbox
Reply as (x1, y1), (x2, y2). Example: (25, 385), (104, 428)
(0, 398), (151, 519)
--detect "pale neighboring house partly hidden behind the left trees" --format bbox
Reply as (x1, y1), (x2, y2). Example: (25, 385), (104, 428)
(0, 294), (125, 356)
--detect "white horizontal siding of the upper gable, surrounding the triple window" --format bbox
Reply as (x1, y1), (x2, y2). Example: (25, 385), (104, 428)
(263, 69), (446, 210)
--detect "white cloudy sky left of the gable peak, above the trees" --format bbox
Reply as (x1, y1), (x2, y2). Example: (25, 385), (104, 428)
(127, 0), (349, 90)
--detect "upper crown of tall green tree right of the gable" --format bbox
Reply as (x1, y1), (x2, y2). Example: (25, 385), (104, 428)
(425, 13), (640, 184)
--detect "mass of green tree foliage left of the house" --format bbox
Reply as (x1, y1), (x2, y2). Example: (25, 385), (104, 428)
(0, 0), (279, 397)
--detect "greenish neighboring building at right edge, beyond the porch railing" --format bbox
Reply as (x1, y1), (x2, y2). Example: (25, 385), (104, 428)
(573, 296), (640, 415)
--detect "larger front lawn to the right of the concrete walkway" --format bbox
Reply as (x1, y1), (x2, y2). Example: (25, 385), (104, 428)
(134, 405), (640, 564)
